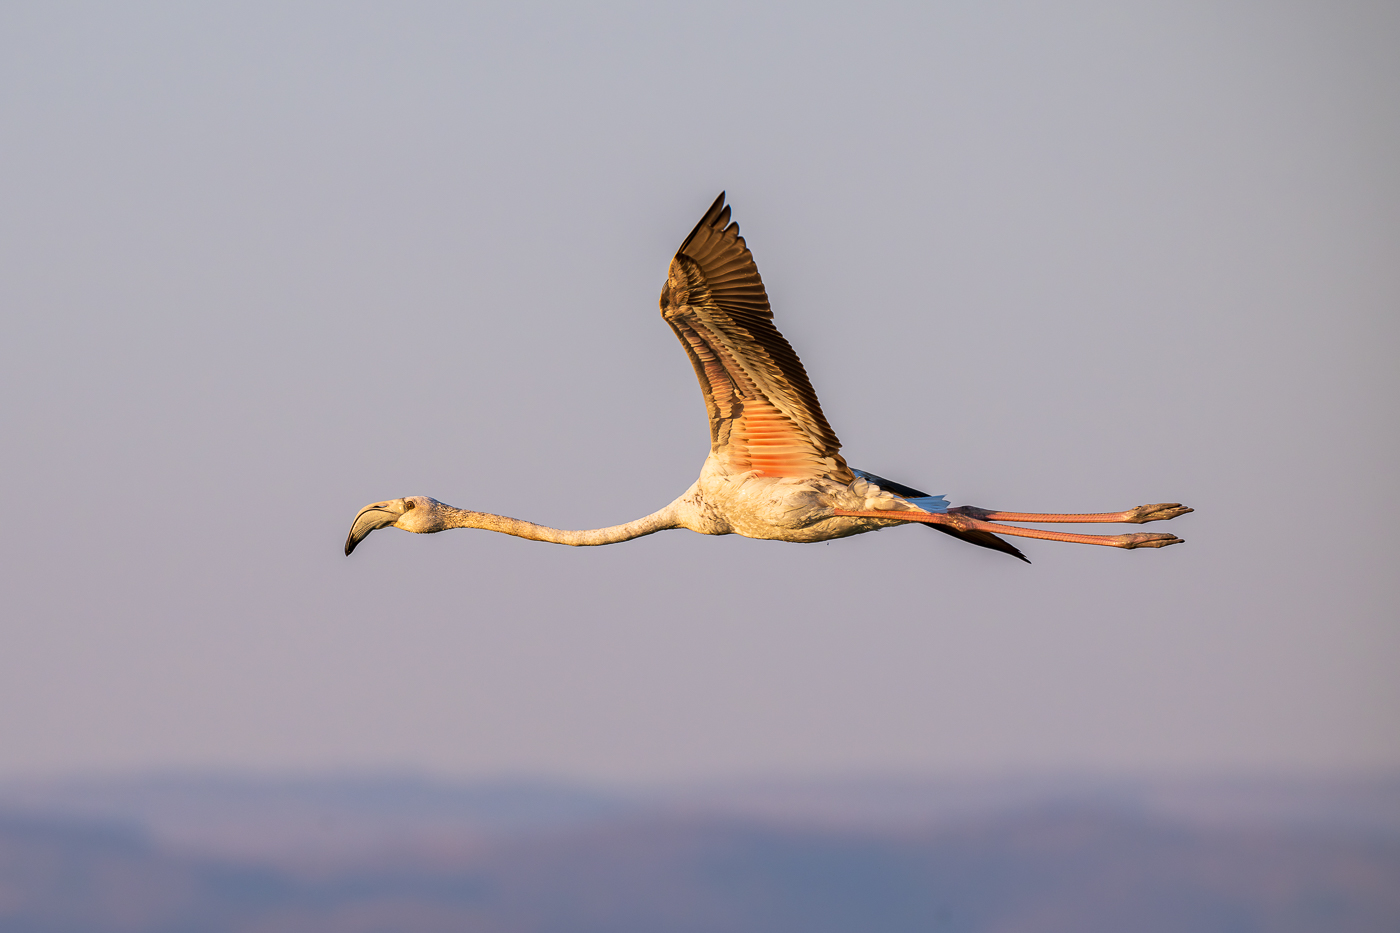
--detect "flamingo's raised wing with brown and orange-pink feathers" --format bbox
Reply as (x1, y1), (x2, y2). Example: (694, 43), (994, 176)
(661, 193), (854, 482)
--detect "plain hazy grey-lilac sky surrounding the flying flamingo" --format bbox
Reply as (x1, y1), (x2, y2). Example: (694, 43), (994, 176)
(0, 0), (1400, 782)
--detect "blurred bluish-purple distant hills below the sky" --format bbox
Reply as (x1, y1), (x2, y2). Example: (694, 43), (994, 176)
(0, 776), (1400, 933)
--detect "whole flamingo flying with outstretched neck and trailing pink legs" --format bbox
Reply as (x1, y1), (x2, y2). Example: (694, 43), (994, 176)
(346, 192), (1191, 563)
